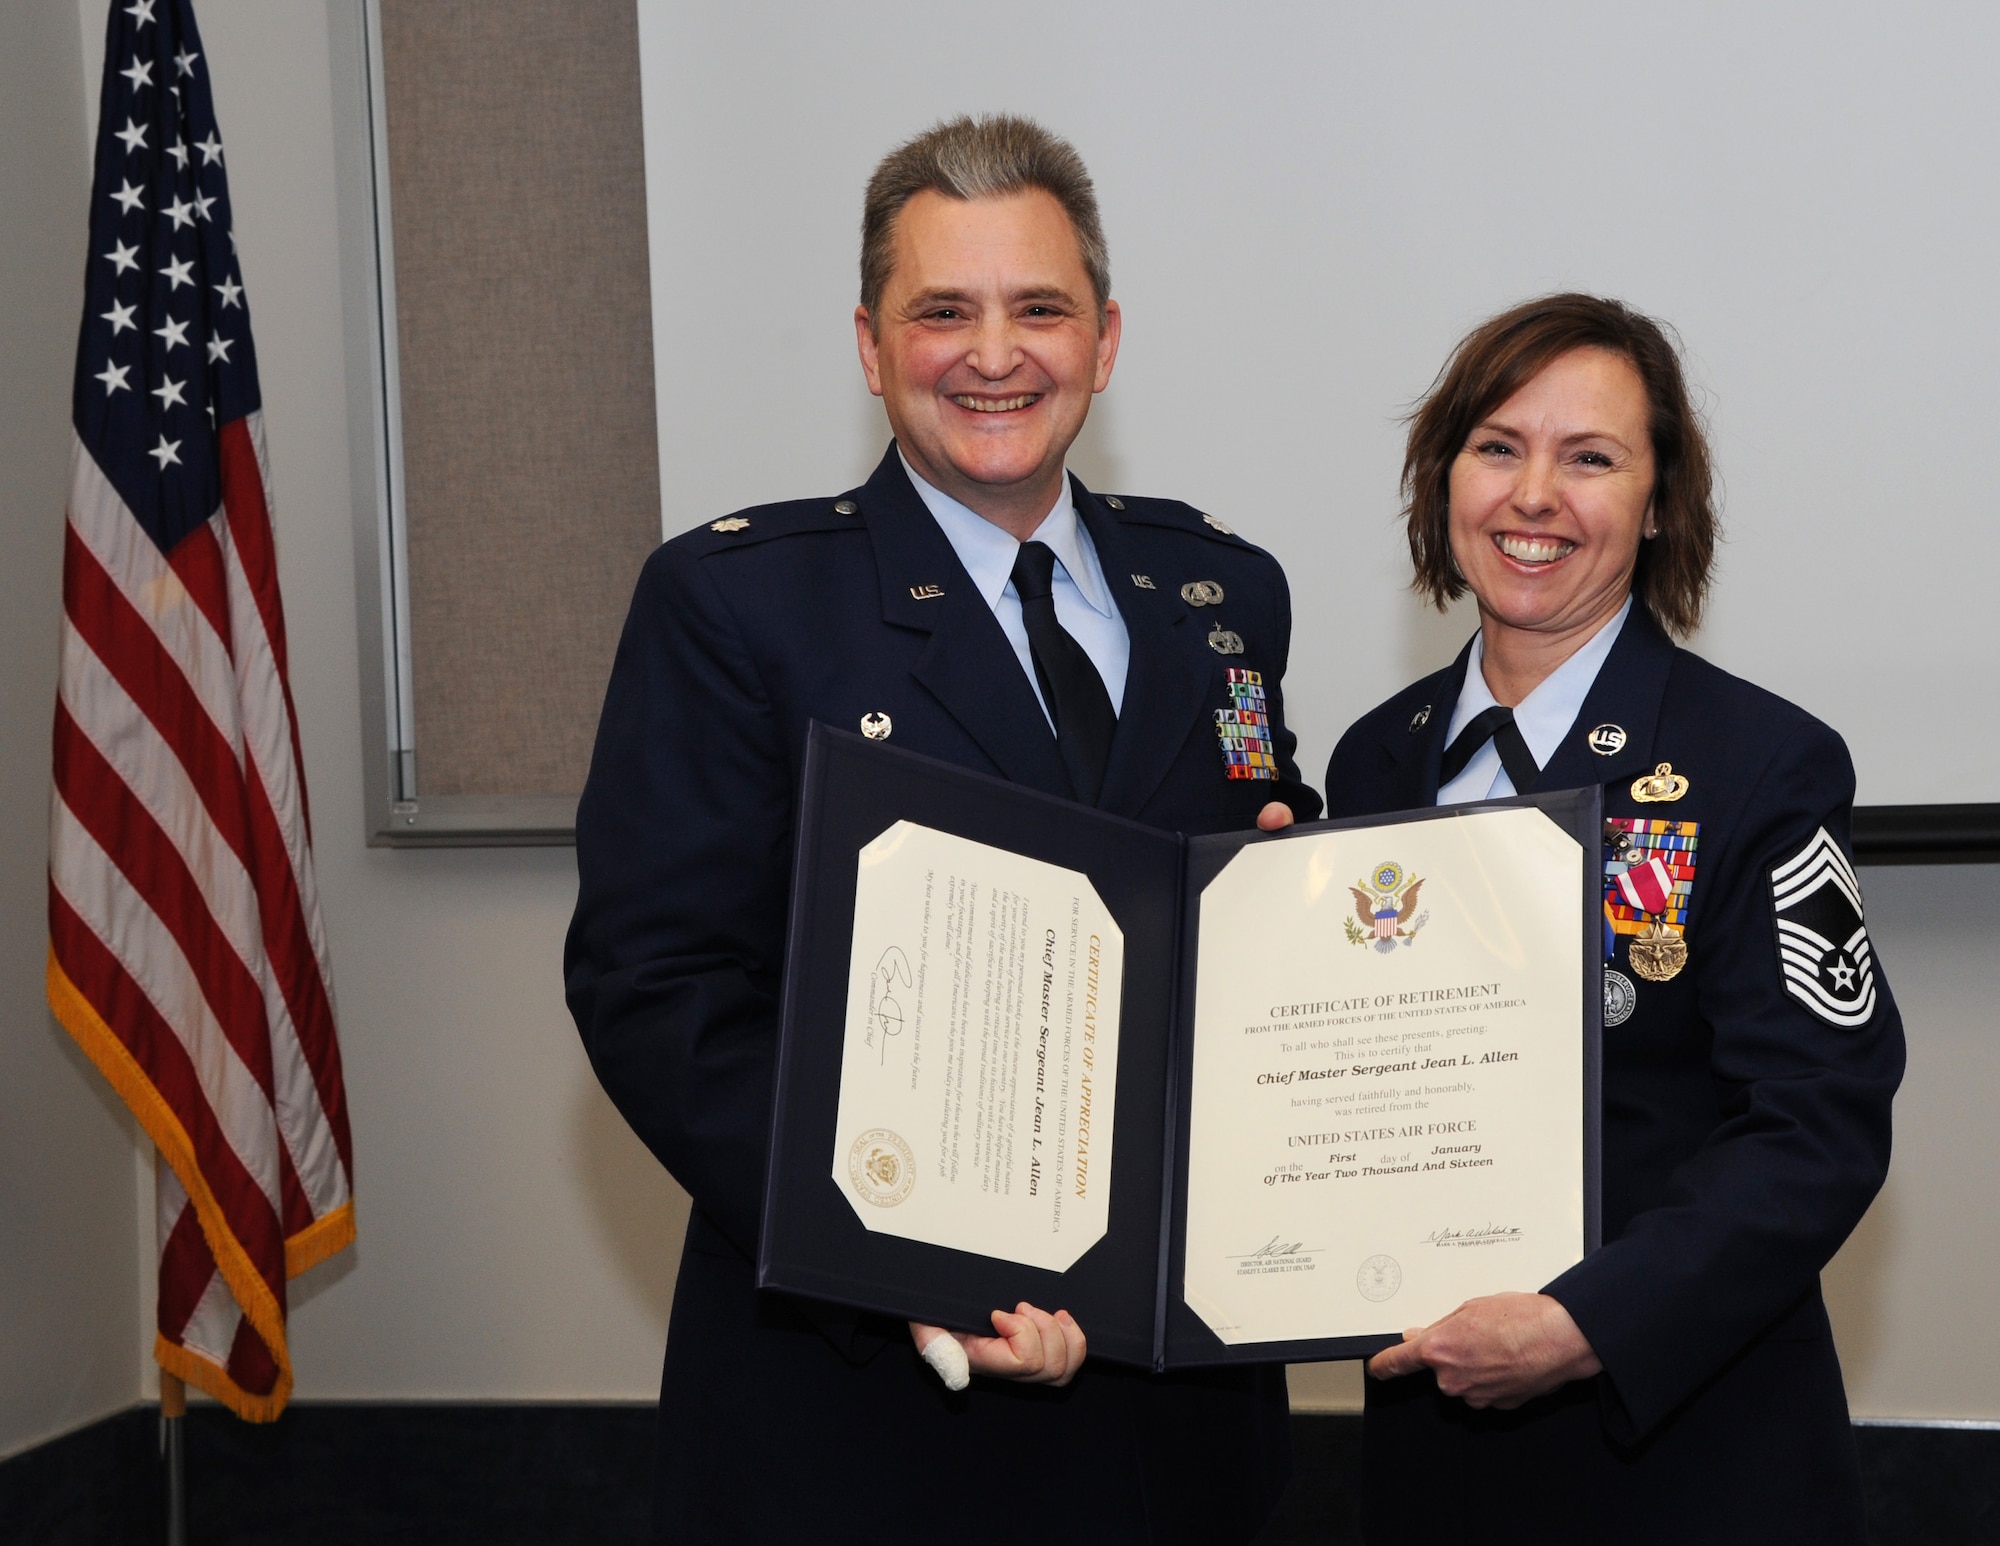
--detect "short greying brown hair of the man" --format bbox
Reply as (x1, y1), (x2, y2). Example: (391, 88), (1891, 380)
(862, 114), (1112, 326)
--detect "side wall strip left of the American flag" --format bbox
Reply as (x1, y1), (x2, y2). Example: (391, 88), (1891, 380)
(0, 4), (140, 1456)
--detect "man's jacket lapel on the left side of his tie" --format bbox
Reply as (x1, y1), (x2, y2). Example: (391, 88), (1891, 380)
(854, 442), (1070, 796)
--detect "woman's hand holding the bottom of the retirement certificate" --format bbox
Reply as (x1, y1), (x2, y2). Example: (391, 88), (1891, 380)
(1368, 1294), (1604, 1412)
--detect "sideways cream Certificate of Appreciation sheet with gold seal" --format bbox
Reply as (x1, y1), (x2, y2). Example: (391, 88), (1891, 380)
(832, 820), (1124, 1272)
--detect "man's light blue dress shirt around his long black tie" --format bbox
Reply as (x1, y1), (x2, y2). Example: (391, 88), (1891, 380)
(896, 450), (1132, 730)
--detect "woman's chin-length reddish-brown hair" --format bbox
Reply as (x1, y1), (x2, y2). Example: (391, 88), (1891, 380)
(1402, 294), (1718, 638)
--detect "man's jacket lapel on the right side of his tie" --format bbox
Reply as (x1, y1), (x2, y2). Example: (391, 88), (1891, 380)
(1070, 476), (1214, 816)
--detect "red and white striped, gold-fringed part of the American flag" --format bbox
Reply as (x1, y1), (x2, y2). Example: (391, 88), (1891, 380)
(50, 414), (354, 1416)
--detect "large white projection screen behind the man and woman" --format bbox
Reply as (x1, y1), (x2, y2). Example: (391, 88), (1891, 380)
(638, 0), (2000, 804)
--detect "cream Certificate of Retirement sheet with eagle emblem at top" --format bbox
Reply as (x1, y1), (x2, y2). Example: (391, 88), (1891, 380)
(1182, 808), (1586, 1346)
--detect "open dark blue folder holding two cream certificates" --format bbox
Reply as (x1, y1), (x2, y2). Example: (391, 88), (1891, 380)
(758, 726), (1602, 1370)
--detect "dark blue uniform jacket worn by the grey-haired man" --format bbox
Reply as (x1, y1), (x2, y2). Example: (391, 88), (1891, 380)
(564, 448), (1320, 1546)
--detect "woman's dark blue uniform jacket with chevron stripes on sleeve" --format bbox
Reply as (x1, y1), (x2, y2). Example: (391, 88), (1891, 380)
(1326, 606), (1902, 1546)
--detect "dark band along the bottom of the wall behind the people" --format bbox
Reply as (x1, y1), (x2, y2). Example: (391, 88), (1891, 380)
(0, 1404), (2000, 1546)
